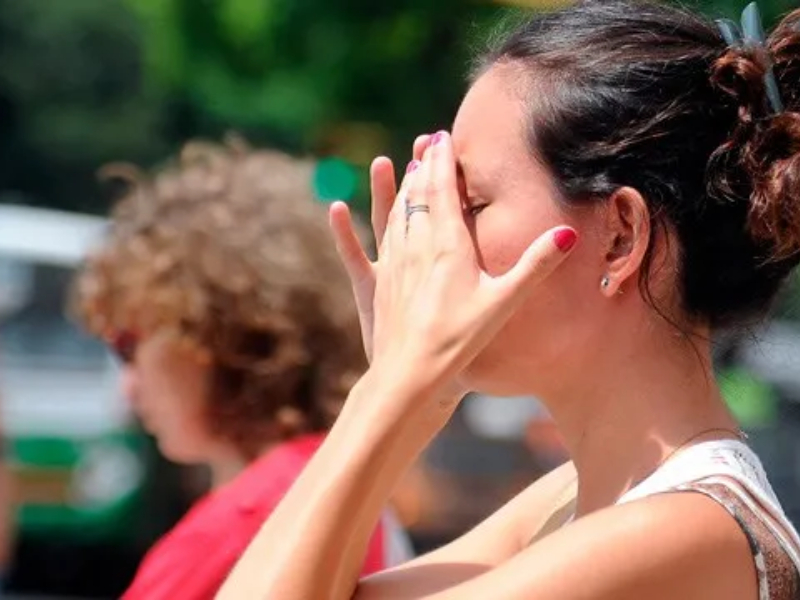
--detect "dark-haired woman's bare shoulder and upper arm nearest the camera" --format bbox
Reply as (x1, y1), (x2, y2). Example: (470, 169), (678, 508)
(472, 493), (758, 600)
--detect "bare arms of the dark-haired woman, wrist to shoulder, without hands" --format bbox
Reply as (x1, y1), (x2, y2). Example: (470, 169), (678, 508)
(218, 370), (756, 600)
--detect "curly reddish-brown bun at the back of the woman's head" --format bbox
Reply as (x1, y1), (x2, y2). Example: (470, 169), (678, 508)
(709, 11), (800, 263)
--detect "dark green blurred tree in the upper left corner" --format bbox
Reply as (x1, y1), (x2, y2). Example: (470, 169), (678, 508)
(0, 0), (169, 210)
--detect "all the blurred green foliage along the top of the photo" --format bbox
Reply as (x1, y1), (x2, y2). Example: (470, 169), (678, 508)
(0, 0), (794, 211)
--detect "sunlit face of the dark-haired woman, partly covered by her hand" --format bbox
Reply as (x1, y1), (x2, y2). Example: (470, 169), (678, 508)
(453, 65), (608, 397)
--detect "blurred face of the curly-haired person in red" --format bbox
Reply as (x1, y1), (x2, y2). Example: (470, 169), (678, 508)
(122, 334), (216, 464)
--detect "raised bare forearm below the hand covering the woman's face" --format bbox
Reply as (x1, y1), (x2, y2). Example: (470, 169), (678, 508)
(218, 376), (456, 600)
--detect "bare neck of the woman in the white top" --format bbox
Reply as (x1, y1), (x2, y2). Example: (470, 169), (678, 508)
(548, 317), (738, 515)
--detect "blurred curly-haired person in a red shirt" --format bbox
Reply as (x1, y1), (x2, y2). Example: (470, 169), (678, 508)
(72, 143), (410, 600)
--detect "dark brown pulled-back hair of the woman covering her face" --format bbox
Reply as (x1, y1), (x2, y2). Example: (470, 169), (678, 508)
(476, 0), (800, 327)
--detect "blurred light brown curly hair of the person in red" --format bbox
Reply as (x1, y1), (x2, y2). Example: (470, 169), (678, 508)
(74, 140), (366, 458)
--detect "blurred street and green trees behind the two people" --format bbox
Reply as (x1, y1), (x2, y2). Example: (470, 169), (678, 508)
(0, 0), (800, 598)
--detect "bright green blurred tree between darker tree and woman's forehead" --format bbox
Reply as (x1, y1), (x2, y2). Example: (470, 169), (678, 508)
(128, 0), (506, 209)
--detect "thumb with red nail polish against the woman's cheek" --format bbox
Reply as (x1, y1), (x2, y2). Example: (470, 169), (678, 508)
(499, 226), (578, 304)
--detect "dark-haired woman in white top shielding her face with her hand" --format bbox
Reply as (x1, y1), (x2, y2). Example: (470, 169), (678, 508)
(219, 0), (800, 600)
